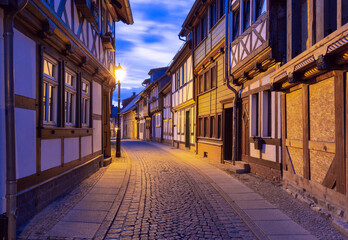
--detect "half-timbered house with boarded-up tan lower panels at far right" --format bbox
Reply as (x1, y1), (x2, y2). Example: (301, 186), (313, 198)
(270, 0), (348, 221)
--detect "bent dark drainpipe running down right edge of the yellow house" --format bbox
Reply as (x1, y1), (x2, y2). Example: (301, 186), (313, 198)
(225, 0), (239, 165)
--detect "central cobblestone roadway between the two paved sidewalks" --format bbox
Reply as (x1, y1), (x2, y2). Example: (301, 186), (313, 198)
(106, 142), (255, 239)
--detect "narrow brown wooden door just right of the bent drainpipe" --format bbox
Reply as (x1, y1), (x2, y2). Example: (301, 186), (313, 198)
(241, 97), (250, 161)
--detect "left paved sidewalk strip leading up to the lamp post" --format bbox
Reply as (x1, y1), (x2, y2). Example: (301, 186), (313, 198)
(18, 149), (130, 240)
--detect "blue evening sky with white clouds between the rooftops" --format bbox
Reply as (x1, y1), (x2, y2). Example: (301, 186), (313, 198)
(113, 0), (194, 105)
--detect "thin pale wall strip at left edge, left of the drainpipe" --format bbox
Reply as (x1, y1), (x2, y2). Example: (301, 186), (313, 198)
(0, 9), (6, 214)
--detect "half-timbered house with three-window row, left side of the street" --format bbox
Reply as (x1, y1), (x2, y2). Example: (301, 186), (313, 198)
(0, 0), (133, 228)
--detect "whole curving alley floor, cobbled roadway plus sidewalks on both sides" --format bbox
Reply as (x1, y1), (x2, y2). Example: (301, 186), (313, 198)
(19, 141), (345, 239)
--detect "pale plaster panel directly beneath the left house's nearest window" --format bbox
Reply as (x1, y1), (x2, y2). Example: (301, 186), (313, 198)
(41, 139), (61, 171)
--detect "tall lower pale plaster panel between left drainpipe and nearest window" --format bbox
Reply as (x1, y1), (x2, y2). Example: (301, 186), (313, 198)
(15, 108), (36, 179)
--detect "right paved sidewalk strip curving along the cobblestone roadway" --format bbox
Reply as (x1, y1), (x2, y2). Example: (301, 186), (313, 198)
(152, 143), (317, 240)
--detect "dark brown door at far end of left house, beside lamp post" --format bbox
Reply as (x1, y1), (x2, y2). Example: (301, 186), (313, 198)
(102, 90), (111, 157)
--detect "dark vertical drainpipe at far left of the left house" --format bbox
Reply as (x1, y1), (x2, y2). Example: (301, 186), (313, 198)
(3, 0), (27, 240)
